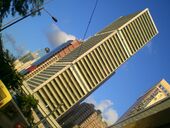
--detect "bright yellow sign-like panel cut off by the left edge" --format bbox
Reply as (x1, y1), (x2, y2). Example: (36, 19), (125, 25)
(0, 80), (12, 108)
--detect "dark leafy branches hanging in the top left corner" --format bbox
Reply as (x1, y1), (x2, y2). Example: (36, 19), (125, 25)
(0, 0), (44, 19)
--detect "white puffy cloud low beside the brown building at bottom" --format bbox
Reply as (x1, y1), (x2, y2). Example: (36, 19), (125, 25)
(85, 97), (118, 125)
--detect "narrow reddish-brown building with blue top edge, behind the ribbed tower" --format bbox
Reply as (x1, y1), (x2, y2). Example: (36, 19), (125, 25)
(23, 40), (81, 79)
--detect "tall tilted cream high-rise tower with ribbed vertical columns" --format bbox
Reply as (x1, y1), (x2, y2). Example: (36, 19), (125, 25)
(23, 9), (158, 127)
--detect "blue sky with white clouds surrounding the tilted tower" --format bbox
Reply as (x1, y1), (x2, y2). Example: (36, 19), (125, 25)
(3, 0), (170, 126)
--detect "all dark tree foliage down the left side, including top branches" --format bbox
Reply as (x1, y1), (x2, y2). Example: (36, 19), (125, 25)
(0, 0), (44, 124)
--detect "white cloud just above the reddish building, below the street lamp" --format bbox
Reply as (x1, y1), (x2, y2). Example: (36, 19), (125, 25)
(47, 24), (75, 46)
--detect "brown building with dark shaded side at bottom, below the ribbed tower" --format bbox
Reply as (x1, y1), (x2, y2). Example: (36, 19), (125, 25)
(57, 102), (107, 128)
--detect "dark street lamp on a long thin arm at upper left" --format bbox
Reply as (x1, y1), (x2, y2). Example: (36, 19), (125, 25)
(0, 7), (58, 32)
